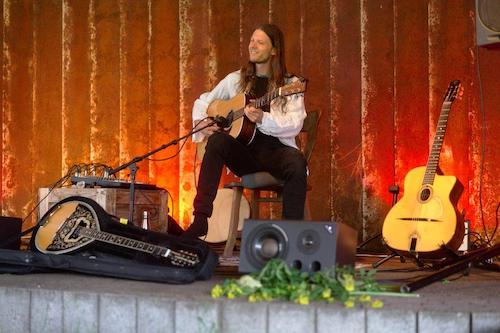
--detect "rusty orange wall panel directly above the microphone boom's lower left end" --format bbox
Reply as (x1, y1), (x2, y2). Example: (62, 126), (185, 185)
(90, 0), (121, 167)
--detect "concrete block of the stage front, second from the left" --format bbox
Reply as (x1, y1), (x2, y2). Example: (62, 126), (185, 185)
(30, 290), (63, 333)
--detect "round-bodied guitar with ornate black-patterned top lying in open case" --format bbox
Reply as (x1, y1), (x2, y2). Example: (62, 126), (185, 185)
(34, 200), (199, 267)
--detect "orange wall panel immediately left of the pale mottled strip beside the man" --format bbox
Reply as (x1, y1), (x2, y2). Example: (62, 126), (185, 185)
(149, 0), (180, 220)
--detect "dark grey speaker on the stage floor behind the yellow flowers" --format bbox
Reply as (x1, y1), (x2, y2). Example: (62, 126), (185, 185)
(239, 220), (357, 273)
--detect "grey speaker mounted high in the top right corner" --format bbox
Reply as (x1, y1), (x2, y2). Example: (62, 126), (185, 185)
(476, 0), (500, 47)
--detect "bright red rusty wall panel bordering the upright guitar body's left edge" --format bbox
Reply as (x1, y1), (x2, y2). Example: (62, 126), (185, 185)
(361, 0), (394, 238)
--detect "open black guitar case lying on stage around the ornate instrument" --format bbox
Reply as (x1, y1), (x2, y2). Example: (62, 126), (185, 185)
(0, 196), (218, 284)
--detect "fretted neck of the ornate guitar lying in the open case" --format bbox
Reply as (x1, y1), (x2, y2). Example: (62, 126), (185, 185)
(78, 227), (173, 257)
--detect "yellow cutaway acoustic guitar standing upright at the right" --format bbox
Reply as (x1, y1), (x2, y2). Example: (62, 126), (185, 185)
(382, 80), (464, 258)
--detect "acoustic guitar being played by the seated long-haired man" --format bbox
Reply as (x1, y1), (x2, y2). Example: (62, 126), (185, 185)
(197, 78), (307, 159)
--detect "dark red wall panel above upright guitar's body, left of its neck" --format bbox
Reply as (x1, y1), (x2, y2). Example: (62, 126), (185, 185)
(393, 1), (429, 191)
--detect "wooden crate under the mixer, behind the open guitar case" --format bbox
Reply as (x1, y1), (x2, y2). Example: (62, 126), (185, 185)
(38, 188), (168, 232)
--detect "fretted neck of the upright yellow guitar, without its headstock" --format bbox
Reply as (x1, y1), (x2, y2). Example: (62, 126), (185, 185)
(422, 101), (452, 185)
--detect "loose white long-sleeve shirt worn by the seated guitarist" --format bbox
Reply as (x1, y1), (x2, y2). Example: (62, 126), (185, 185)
(193, 70), (306, 148)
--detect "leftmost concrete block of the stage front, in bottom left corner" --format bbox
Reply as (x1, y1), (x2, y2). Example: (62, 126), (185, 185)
(0, 288), (31, 333)
